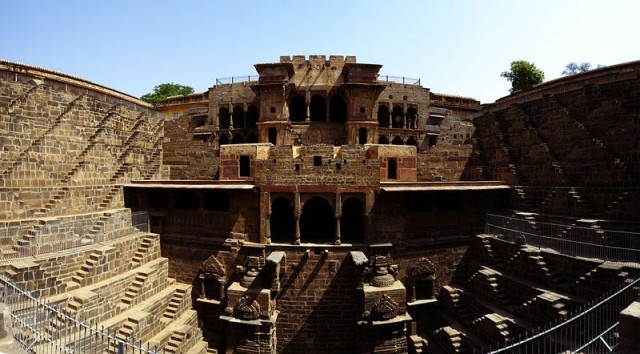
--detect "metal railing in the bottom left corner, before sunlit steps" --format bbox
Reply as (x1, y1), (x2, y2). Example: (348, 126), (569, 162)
(0, 275), (164, 354)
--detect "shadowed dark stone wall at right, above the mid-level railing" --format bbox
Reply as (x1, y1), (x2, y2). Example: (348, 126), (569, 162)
(463, 62), (640, 219)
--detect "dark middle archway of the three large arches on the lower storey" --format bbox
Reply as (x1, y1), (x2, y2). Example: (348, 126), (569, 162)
(300, 197), (336, 243)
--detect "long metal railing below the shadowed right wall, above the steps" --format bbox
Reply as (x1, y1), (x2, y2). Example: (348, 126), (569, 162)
(485, 214), (640, 263)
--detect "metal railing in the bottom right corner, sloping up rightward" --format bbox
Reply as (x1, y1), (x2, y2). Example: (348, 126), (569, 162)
(483, 278), (640, 354)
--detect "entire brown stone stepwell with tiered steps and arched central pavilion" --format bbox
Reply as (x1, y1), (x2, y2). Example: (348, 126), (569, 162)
(0, 56), (640, 353)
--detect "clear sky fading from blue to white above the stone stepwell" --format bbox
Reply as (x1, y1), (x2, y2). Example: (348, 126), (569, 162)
(0, 0), (640, 102)
